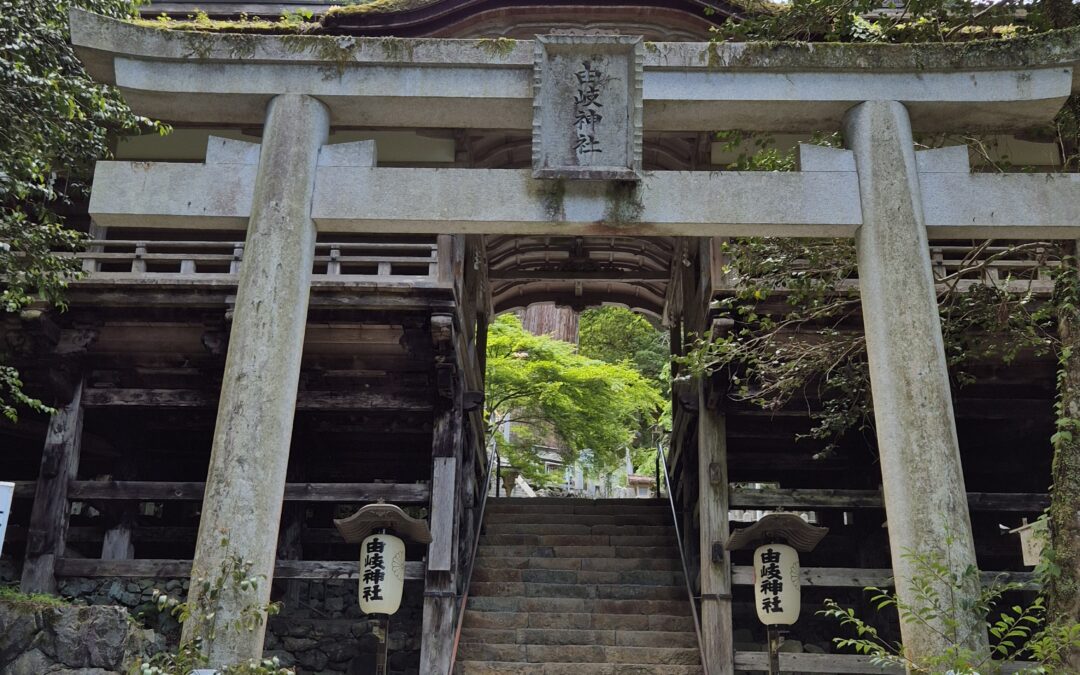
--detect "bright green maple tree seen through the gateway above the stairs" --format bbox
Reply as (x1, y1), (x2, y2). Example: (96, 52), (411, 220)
(484, 314), (663, 481)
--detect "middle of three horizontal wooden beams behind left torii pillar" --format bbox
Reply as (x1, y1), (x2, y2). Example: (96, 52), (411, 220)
(68, 481), (431, 504)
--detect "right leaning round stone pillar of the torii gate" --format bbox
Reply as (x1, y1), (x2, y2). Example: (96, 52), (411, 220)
(845, 100), (988, 661)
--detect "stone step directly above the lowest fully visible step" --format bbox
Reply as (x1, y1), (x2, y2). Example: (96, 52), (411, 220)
(461, 629), (698, 648)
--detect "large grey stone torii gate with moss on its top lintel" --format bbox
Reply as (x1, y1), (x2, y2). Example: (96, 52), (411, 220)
(72, 11), (1080, 674)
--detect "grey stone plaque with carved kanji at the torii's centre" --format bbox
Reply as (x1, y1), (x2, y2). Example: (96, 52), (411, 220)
(532, 35), (644, 180)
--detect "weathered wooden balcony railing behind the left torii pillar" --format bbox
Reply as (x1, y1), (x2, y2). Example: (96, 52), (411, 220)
(73, 235), (449, 285)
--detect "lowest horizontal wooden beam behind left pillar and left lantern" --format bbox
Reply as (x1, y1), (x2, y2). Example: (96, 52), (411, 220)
(56, 558), (423, 581)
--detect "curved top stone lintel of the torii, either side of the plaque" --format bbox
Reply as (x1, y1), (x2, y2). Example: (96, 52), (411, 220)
(71, 11), (1080, 132)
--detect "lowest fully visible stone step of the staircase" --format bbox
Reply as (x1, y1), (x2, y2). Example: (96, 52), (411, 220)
(458, 643), (701, 665)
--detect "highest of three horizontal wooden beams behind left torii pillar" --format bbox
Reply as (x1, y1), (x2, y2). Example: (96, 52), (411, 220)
(83, 389), (431, 411)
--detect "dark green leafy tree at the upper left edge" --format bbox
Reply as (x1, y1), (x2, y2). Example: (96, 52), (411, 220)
(0, 0), (166, 420)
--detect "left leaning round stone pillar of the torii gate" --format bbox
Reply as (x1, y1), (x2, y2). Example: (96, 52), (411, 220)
(184, 94), (329, 667)
